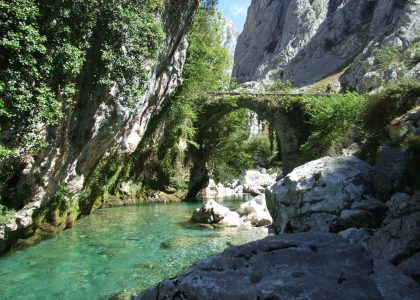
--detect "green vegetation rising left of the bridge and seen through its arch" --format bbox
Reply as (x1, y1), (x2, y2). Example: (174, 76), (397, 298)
(150, 2), (271, 188)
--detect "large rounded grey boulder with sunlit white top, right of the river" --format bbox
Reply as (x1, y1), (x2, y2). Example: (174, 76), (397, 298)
(265, 156), (386, 233)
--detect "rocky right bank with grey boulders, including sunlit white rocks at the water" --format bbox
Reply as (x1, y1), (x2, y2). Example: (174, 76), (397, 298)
(135, 154), (420, 300)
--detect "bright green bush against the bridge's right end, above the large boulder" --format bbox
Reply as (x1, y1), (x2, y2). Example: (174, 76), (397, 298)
(301, 93), (366, 159)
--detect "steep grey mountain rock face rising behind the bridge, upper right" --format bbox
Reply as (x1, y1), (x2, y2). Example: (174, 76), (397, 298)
(233, 0), (420, 92)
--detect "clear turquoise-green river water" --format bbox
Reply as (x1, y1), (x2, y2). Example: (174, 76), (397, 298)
(0, 198), (265, 300)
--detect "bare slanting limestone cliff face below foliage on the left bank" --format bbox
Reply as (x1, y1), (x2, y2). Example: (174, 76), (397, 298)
(0, 0), (198, 253)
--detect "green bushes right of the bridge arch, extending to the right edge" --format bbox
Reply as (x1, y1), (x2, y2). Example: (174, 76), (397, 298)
(302, 80), (420, 163)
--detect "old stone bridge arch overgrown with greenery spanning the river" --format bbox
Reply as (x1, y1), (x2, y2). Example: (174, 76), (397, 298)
(187, 93), (308, 198)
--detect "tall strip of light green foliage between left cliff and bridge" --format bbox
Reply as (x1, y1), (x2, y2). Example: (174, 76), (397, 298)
(159, 1), (231, 186)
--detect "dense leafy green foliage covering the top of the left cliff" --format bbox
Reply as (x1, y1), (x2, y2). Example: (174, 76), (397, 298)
(0, 0), (164, 150)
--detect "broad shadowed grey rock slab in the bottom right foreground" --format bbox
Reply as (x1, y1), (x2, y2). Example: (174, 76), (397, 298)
(135, 233), (420, 300)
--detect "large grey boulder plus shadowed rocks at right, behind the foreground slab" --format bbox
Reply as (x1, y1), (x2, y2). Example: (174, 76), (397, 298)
(266, 157), (420, 280)
